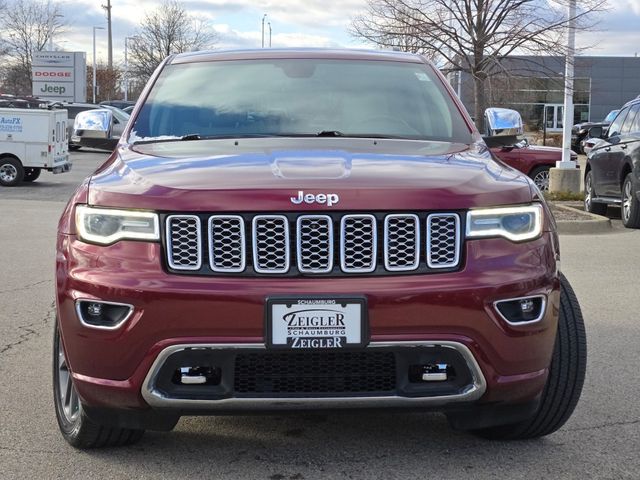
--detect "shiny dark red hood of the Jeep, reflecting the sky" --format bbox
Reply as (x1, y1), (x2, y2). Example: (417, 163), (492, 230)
(89, 138), (532, 212)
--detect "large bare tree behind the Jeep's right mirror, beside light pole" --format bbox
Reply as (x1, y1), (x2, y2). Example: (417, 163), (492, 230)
(351, 0), (607, 129)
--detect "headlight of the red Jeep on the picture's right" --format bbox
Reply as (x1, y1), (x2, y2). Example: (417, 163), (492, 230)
(467, 205), (542, 242)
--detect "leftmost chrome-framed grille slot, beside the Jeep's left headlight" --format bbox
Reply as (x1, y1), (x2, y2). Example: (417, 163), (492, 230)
(167, 215), (202, 270)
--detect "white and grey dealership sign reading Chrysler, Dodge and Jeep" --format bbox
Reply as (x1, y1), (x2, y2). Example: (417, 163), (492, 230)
(32, 52), (87, 102)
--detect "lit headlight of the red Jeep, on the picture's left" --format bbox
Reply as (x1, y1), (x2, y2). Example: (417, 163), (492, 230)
(76, 205), (160, 245)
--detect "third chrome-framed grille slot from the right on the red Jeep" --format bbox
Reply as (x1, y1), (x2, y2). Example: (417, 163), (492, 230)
(340, 215), (378, 273)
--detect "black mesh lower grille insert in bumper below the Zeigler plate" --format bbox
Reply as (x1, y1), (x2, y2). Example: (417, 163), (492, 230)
(235, 352), (396, 395)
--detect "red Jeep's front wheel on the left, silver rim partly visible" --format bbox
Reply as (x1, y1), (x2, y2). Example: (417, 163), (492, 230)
(53, 325), (144, 449)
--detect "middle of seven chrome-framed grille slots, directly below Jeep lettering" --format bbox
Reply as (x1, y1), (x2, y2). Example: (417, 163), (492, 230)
(296, 215), (333, 273)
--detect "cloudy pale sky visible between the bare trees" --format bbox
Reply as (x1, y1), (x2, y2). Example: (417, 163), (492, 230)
(52, 0), (640, 62)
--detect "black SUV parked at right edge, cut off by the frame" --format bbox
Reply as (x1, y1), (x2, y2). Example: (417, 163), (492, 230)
(584, 97), (640, 228)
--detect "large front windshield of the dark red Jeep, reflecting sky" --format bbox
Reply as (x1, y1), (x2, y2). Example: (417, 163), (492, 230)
(129, 59), (471, 143)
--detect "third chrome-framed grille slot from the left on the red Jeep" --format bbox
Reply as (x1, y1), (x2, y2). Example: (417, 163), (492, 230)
(253, 215), (289, 273)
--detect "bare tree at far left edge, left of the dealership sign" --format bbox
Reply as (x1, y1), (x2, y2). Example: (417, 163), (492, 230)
(0, 0), (65, 93)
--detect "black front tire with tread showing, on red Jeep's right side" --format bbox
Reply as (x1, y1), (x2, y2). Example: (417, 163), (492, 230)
(474, 275), (587, 440)
